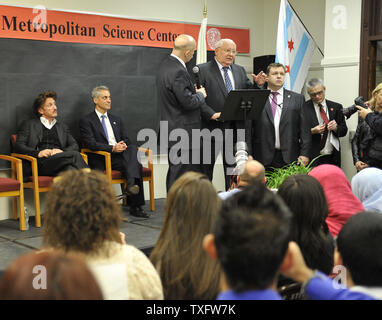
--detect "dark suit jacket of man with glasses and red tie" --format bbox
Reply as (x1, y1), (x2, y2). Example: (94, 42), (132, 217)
(304, 100), (348, 166)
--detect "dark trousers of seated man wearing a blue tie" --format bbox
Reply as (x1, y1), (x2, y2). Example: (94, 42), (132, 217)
(111, 144), (145, 207)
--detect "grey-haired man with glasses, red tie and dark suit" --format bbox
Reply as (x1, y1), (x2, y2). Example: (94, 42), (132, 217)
(304, 78), (348, 167)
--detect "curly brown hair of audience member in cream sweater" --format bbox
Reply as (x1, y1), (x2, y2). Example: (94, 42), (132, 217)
(43, 170), (122, 254)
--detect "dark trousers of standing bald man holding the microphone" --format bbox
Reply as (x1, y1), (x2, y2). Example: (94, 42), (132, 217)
(166, 149), (202, 192)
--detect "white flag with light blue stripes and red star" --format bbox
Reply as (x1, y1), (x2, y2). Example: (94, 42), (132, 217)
(276, 0), (316, 93)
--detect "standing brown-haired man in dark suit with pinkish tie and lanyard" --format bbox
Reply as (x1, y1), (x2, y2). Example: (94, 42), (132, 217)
(252, 63), (312, 170)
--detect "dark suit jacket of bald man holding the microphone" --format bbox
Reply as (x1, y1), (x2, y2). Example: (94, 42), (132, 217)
(156, 56), (204, 150)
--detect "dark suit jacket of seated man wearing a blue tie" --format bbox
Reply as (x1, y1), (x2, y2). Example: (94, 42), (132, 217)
(80, 111), (130, 170)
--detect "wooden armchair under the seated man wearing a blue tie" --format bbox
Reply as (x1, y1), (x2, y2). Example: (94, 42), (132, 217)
(81, 147), (155, 211)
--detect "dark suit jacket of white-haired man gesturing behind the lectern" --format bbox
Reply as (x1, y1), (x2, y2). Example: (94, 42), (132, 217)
(199, 59), (258, 152)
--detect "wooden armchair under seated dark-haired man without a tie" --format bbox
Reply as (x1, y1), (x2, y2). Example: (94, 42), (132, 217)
(11, 134), (88, 228)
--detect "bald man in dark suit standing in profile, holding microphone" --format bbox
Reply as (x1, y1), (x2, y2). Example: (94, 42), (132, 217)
(156, 34), (207, 191)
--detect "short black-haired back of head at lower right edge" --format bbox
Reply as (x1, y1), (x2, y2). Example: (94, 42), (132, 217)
(337, 212), (382, 287)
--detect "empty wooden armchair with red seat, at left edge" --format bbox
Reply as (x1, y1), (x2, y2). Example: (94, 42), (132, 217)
(0, 155), (26, 231)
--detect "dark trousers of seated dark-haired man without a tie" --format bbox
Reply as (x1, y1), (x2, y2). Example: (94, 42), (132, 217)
(38, 151), (88, 176)
